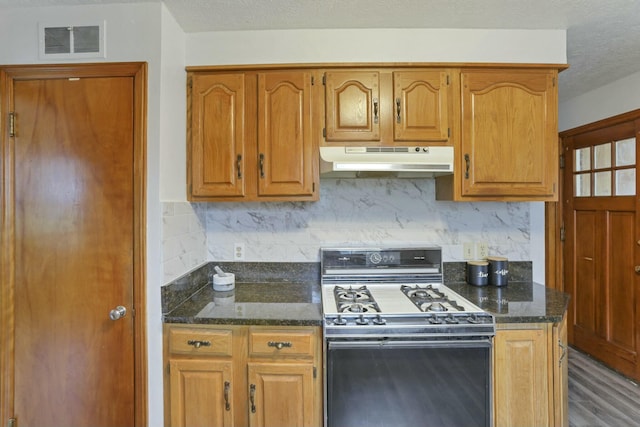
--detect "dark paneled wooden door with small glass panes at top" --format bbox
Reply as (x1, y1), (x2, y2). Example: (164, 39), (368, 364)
(563, 118), (640, 379)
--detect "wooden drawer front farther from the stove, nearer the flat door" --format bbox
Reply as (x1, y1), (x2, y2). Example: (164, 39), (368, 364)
(169, 328), (233, 356)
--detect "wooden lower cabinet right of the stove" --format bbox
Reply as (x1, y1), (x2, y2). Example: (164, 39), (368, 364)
(494, 318), (569, 427)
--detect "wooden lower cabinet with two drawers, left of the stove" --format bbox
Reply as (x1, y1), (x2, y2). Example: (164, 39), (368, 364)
(164, 324), (322, 427)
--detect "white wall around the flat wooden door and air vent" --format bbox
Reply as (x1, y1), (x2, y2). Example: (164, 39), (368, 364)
(0, 3), (169, 426)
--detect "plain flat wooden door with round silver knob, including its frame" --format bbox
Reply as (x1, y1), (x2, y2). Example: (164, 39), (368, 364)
(2, 64), (145, 427)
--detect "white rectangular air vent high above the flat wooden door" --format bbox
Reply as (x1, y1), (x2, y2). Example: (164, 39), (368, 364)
(40, 22), (106, 59)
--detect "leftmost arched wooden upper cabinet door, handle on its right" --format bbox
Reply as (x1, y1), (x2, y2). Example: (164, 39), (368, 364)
(187, 73), (246, 199)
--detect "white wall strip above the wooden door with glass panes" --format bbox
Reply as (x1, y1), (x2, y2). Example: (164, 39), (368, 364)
(558, 72), (640, 131)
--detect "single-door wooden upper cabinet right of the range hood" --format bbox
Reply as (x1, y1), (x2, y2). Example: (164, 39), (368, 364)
(442, 69), (558, 201)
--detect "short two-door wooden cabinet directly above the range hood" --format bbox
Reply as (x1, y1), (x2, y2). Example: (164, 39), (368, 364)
(323, 69), (453, 146)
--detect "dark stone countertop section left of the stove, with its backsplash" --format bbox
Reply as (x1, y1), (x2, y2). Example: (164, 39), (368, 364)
(162, 263), (322, 326)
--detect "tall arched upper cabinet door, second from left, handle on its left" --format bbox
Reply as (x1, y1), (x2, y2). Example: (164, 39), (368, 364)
(258, 71), (317, 197)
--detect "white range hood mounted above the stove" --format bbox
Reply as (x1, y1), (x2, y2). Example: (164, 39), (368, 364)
(320, 147), (453, 178)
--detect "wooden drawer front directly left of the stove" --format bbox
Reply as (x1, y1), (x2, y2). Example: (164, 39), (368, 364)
(249, 329), (316, 357)
